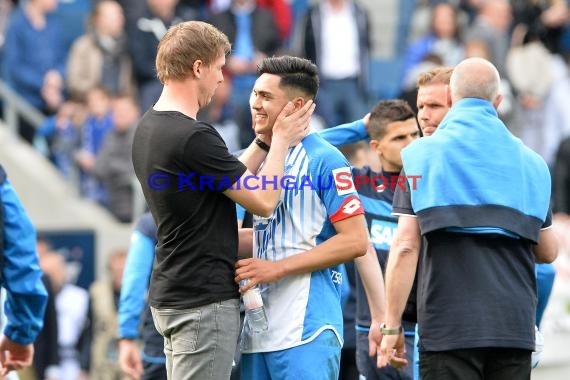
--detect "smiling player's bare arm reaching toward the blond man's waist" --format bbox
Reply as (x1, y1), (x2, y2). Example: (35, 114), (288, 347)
(235, 214), (368, 292)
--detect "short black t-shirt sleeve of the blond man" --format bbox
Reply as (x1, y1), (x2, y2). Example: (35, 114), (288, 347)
(184, 123), (247, 191)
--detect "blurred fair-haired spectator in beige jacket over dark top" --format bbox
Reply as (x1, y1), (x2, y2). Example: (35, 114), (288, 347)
(67, 0), (135, 99)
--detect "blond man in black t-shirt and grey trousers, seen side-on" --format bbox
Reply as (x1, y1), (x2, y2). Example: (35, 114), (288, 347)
(133, 21), (314, 380)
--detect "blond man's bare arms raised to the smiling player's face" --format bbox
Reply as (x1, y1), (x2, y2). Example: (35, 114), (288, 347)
(224, 101), (315, 217)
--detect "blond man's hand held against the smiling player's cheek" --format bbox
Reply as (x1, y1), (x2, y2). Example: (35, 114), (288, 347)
(273, 100), (315, 147)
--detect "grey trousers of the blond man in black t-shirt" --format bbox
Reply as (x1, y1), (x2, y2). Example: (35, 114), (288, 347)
(150, 299), (239, 380)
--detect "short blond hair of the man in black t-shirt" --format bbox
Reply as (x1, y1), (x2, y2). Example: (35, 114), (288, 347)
(156, 21), (231, 84)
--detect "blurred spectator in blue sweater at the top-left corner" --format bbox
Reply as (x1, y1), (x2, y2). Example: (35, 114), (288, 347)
(3, 0), (67, 143)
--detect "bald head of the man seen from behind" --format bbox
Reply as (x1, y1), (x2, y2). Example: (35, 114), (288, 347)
(449, 58), (500, 103)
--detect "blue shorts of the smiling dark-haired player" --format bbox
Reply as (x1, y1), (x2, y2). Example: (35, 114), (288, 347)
(241, 330), (341, 380)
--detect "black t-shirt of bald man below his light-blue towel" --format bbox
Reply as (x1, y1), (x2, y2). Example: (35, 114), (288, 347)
(393, 177), (551, 351)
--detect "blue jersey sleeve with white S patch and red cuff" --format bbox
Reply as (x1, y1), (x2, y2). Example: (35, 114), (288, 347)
(312, 148), (364, 223)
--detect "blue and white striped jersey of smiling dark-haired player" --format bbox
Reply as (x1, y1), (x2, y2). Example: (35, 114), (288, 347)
(243, 134), (364, 352)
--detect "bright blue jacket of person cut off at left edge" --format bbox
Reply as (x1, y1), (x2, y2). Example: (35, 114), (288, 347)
(0, 166), (47, 344)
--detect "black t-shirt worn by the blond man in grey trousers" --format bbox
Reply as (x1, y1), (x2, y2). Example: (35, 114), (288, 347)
(133, 109), (246, 309)
